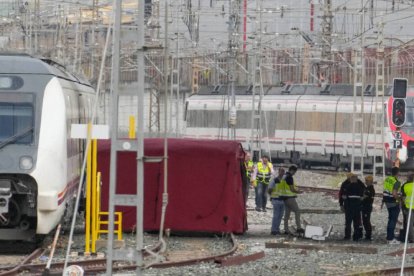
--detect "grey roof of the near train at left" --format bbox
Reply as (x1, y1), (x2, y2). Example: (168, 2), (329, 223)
(0, 53), (90, 86)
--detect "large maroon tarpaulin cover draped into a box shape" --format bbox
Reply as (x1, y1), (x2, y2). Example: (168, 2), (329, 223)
(98, 138), (247, 234)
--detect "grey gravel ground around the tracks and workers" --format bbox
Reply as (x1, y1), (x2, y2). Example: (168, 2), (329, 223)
(4, 171), (414, 276)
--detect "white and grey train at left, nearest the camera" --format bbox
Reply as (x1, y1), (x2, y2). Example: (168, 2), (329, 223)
(0, 54), (94, 240)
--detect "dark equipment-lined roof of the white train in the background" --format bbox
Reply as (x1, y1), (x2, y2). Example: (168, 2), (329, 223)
(198, 84), (392, 97)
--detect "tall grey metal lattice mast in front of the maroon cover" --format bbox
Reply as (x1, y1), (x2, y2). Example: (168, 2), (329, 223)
(106, 0), (145, 275)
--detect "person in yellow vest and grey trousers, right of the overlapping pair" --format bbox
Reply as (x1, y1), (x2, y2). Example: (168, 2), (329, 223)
(280, 165), (305, 234)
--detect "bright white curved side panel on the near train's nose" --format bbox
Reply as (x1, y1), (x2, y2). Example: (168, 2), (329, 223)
(32, 78), (68, 234)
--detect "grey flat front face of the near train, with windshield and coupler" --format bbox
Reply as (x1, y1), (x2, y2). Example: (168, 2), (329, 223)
(0, 74), (41, 240)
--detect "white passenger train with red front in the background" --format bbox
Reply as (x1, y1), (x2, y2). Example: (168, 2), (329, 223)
(184, 84), (414, 168)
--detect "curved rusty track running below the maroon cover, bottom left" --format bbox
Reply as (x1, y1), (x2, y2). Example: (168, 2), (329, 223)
(0, 235), (238, 276)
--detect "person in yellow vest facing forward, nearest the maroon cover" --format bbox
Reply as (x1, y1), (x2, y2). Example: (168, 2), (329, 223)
(255, 155), (273, 212)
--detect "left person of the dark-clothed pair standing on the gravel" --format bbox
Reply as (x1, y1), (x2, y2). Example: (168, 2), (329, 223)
(344, 173), (365, 241)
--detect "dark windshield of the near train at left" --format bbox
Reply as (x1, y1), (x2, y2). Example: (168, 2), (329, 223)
(0, 93), (34, 148)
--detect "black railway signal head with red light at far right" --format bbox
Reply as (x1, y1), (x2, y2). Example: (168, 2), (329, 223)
(392, 78), (408, 127)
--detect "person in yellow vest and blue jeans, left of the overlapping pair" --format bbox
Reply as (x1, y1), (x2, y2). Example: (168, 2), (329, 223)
(268, 168), (285, 235)
